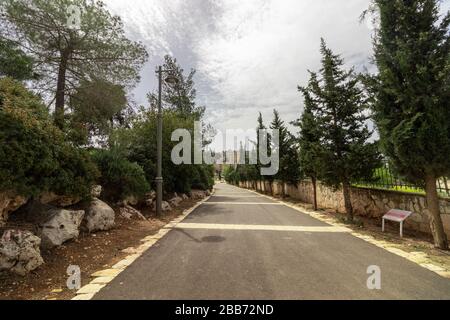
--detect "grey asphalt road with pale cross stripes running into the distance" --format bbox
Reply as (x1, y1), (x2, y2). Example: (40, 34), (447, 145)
(94, 184), (450, 300)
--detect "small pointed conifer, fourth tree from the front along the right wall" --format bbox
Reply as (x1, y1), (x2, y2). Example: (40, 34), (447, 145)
(270, 110), (300, 196)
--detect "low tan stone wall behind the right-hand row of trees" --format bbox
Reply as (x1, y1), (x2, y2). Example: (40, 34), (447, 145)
(241, 181), (450, 238)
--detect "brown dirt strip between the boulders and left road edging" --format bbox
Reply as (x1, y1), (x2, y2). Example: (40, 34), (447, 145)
(0, 200), (197, 300)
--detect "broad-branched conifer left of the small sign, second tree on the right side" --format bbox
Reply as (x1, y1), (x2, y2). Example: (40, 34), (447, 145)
(308, 39), (380, 221)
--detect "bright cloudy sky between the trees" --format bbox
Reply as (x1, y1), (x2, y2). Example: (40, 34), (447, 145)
(106, 0), (450, 150)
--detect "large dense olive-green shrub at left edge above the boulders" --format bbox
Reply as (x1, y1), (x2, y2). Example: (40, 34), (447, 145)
(0, 78), (98, 197)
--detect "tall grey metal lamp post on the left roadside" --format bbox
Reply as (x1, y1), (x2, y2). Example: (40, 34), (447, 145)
(155, 66), (178, 217)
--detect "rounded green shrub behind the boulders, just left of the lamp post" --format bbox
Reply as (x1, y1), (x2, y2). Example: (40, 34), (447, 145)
(92, 149), (150, 201)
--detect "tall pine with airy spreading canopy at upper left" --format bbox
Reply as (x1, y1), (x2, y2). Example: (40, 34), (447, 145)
(0, 0), (148, 128)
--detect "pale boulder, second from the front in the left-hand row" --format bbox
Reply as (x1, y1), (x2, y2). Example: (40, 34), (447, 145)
(38, 208), (85, 249)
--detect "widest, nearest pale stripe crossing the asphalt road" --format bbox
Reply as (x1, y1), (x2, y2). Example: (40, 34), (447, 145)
(175, 223), (351, 233)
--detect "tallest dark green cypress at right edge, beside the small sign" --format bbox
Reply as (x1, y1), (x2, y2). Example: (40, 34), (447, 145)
(372, 0), (450, 249)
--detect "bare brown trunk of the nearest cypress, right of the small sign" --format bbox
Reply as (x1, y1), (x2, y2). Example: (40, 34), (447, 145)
(425, 174), (448, 250)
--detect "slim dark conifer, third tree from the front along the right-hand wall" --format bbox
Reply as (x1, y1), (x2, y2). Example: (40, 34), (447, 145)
(293, 79), (321, 210)
